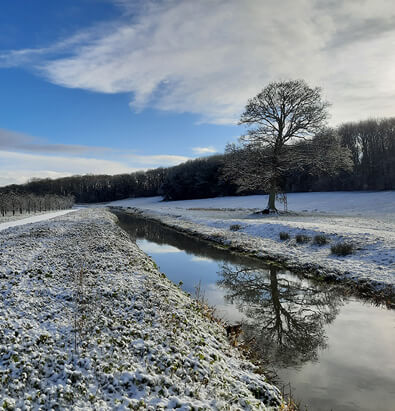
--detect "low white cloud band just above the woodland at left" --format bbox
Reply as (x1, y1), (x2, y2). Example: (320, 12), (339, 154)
(0, 129), (189, 186)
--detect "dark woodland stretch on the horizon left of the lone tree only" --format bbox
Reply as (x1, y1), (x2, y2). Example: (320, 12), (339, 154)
(0, 155), (237, 203)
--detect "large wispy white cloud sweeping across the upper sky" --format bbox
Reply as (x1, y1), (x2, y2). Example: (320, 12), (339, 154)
(0, 0), (395, 124)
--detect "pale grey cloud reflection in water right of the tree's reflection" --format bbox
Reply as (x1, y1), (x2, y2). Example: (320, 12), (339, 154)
(279, 301), (395, 411)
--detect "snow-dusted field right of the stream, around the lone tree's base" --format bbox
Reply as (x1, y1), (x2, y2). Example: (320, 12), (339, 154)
(102, 191), (395, 298)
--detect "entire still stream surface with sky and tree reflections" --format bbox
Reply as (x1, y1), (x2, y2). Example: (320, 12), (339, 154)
(118, 213), (395, 411)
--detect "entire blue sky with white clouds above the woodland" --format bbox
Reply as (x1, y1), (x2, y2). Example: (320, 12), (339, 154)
(0, 0), (395, 185)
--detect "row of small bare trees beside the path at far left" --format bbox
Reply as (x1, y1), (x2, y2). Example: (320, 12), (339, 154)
(0, 192), (74, 217)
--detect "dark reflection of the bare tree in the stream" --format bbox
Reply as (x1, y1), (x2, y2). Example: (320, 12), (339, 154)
(218, 264), (342, 367)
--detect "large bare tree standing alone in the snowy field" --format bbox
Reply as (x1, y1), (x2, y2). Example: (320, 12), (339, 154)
(224, 80), (329, 212)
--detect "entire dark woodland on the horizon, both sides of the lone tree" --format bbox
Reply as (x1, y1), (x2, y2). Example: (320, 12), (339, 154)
(0, 118), (395, 204)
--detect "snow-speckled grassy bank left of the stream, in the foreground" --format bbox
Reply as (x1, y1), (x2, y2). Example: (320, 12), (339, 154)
(0, 209), (281, 409)
